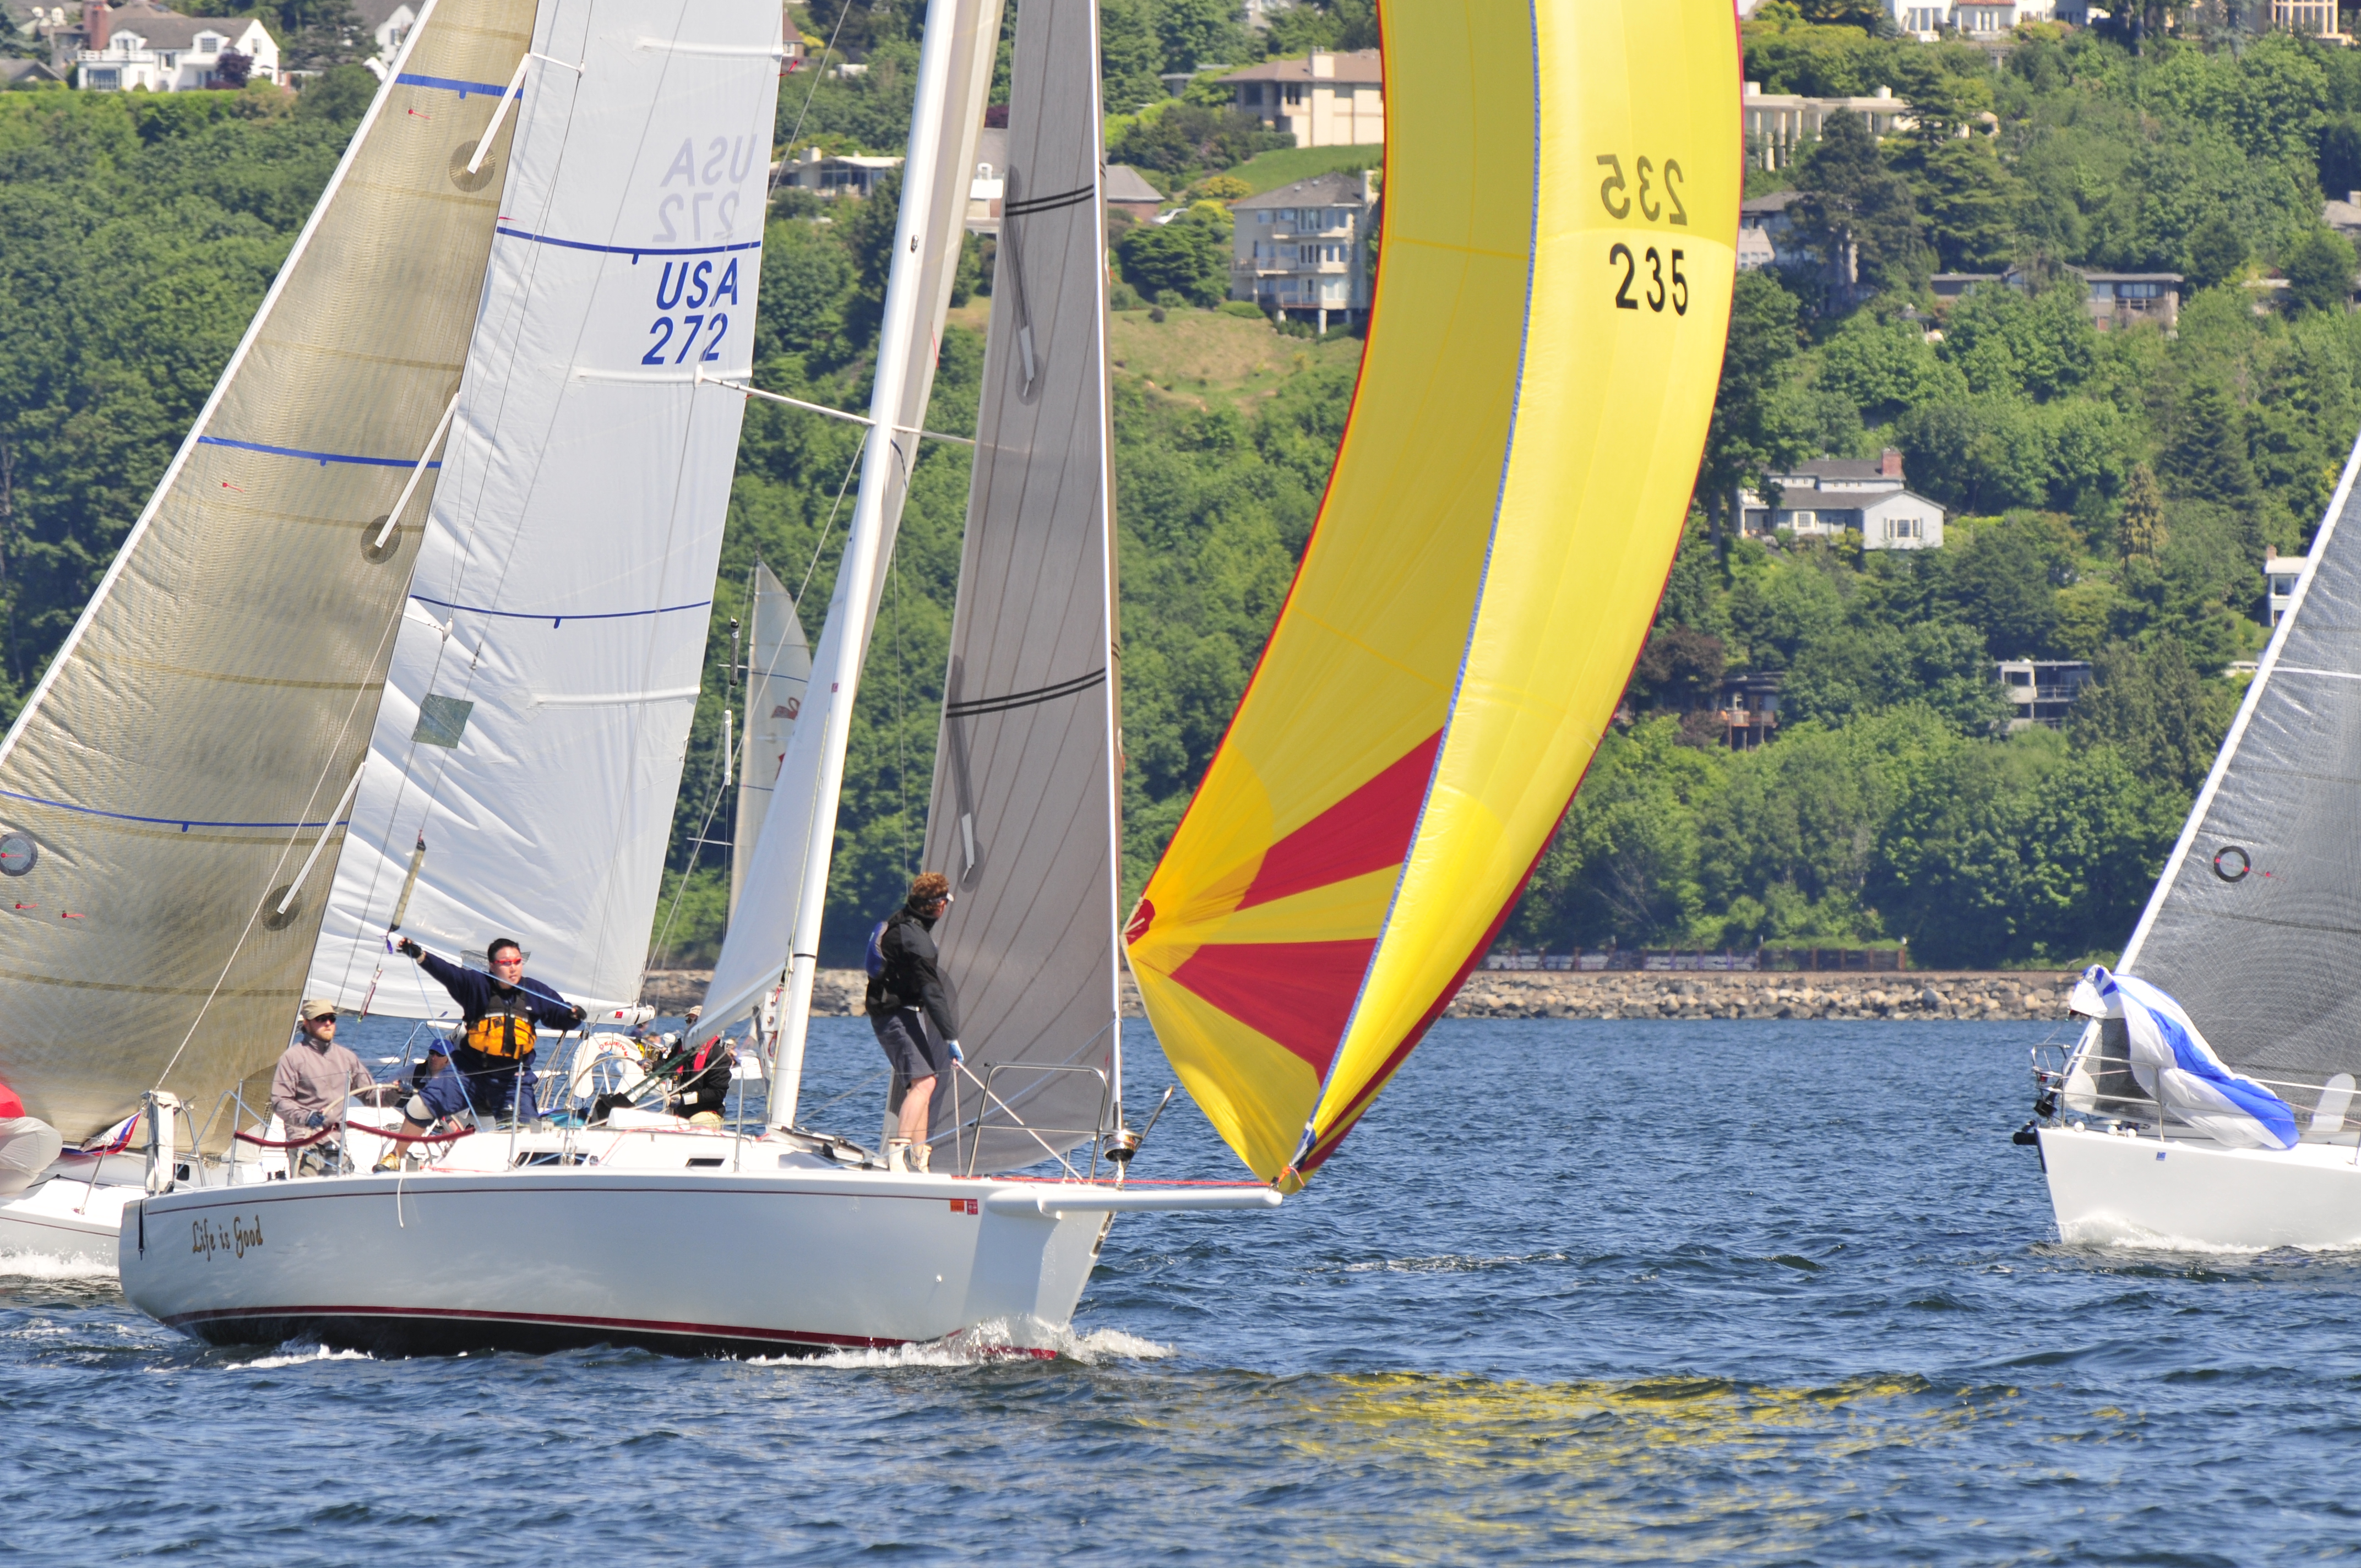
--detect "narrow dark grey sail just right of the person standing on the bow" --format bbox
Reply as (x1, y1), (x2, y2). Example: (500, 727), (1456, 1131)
(926, 0), (1122, 1171)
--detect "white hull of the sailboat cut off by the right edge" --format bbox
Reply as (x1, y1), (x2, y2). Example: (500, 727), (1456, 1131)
(2040, 1126), (2361, 1251)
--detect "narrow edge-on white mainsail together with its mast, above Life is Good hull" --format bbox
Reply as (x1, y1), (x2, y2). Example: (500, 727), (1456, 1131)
(697, 0), (1001, 1076)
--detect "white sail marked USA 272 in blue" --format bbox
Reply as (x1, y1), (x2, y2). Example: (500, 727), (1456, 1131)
(304, 0), (779, 1018)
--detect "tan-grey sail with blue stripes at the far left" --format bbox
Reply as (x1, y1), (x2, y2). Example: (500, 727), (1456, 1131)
(0, 0), (534, 1138)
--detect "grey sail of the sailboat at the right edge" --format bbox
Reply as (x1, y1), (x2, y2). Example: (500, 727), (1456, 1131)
(2106, 429), (2361, 1112)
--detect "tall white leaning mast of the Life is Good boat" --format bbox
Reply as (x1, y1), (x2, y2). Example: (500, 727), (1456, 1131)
(769, 0), (1001, 1126)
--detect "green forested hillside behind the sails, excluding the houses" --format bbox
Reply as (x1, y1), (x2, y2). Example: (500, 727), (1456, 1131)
(0, 0), (2361, 963)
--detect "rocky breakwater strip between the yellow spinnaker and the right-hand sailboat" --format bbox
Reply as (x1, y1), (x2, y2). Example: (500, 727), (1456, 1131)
(1445, 971), (2075, 1020)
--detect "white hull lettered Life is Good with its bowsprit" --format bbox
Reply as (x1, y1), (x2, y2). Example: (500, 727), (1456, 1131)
(121, 1134), (1275, 1355)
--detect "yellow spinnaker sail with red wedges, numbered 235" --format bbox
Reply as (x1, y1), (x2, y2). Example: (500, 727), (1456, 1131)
(1126, 0), (1743, 1185)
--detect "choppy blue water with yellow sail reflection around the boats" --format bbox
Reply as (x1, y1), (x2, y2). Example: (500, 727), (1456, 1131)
(0, 1020), (2361, 1566)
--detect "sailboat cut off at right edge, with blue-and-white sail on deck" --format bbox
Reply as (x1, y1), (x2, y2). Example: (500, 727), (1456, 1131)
(2019, 429), (2361, 1249)
